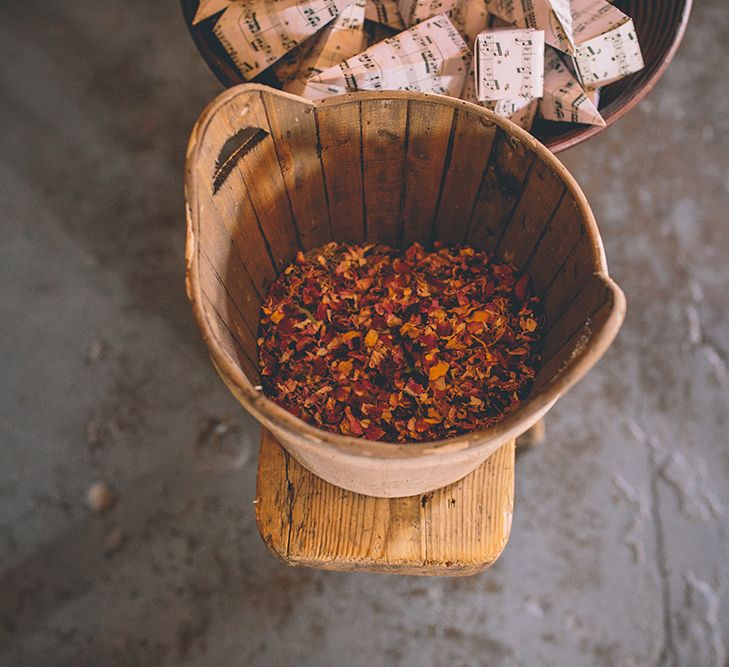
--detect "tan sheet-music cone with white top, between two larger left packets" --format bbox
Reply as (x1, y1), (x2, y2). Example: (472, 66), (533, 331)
(283, 0), (367, 99)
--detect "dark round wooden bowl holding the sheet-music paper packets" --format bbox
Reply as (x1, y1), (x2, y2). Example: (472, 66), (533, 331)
(181, 0), (692, 153)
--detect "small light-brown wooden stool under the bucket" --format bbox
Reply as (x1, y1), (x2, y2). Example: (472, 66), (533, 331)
(255, 429), (515, 576)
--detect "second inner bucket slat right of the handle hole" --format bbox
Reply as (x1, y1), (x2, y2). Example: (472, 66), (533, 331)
(315, 104), (365, 243)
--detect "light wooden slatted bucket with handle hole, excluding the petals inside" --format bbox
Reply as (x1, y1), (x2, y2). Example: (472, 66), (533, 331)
(186, 84), (625, 497)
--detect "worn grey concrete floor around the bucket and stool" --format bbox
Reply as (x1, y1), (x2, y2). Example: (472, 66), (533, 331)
(0, 0), (729, 667)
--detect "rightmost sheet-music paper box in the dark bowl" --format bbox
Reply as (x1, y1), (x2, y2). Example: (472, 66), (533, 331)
(572, 0), (644, 86)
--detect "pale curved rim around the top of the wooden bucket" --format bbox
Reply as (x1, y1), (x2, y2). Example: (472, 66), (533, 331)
(185, 84), (626, 462)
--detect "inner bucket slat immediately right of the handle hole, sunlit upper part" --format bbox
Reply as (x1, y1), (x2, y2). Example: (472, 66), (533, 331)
(263, 95), (332, 250)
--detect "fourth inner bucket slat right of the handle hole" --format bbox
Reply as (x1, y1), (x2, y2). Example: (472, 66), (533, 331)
(402, 102), (453, 247)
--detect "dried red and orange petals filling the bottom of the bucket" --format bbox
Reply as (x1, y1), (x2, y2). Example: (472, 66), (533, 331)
(258, 243), (542, 442)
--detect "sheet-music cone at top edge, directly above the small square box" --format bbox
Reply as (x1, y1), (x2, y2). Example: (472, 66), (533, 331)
(486, 0), (575, 53)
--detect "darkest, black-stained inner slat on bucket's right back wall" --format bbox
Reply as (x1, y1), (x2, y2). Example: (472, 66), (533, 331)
(467, 130), (534, 251)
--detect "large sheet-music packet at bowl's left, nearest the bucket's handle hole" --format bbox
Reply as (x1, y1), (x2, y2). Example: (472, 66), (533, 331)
(214, 0), (352, 80)
